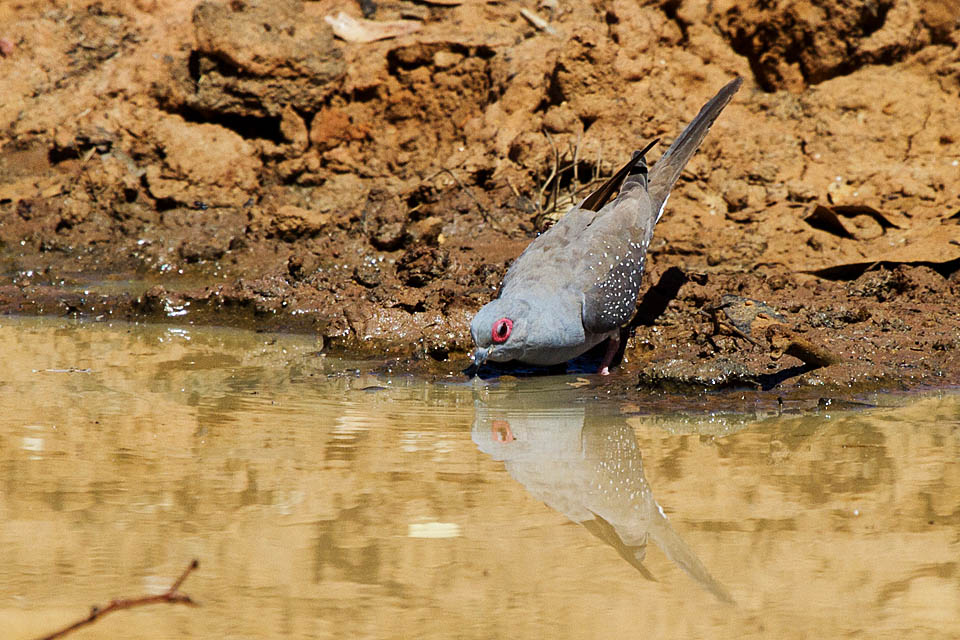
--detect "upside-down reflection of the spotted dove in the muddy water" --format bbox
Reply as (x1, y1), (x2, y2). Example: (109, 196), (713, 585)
(473, 399), (733, 602)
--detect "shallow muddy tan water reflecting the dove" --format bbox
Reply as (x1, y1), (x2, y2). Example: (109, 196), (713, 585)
(0, 318), (960, 639)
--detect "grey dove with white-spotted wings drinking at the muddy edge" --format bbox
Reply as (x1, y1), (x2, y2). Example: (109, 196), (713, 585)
(470, 77), (743, 375)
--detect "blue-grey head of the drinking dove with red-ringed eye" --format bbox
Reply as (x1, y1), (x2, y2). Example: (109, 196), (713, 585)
(470, 298), (532, 366)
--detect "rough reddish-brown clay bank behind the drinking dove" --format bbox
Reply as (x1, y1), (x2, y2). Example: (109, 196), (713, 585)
(0, 0), (960, 391)
